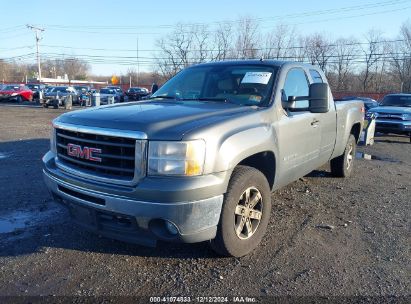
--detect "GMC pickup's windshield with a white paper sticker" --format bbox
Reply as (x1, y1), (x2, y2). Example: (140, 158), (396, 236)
(152, 64), (277, 106)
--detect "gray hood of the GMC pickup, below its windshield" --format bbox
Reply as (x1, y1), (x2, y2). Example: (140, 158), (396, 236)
(56, 101), (256, 140)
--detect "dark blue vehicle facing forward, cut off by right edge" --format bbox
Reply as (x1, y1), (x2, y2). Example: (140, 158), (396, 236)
(366, 94), (411, 142)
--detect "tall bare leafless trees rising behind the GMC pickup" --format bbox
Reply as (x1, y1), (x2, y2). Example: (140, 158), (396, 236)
(155, 18), (411, 92)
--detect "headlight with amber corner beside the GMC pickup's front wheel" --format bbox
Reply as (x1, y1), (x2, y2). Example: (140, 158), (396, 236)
(148, 140), (205, 176)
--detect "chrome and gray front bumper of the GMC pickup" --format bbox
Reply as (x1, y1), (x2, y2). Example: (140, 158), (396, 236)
(43, 152), (228, 246)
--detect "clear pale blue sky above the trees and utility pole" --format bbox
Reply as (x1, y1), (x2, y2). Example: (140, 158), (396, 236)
(0, 0), (411, 75)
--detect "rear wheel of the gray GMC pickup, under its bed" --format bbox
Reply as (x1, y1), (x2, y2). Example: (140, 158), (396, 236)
(330, 134), (357, 177)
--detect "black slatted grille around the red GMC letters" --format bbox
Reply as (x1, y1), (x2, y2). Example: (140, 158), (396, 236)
(56, 129), (136, 180)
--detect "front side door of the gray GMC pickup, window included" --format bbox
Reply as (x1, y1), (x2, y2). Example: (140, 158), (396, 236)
(278, 67), (321, 181)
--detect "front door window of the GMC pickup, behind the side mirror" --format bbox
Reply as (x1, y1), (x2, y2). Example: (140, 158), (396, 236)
(284, 68), (309, 108)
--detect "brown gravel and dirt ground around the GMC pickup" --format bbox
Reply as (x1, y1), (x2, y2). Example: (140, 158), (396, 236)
(0, 104), (411, 303)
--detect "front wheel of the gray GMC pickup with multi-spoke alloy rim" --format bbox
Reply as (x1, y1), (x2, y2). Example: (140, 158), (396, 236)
(210, 166), (271, 257)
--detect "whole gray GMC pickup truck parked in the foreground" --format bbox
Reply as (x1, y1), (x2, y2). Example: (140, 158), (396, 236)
(43, 60), (364, 256)
